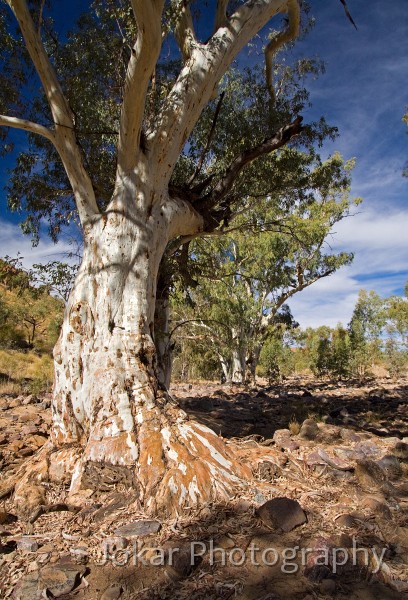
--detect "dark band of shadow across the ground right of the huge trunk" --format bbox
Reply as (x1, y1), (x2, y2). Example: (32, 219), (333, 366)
(174, 382), (408, 439)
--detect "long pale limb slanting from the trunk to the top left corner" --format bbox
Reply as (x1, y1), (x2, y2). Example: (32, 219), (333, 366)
(6, 0), (99, 225)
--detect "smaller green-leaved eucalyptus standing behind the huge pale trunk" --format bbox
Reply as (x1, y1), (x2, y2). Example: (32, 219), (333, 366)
(171, 148), (359, 383)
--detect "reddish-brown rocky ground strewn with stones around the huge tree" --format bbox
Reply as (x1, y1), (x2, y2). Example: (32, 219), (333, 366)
(0, 379), (408, 600)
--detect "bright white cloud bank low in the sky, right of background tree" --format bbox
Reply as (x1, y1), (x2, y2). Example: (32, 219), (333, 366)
(289, 209), (408, 327)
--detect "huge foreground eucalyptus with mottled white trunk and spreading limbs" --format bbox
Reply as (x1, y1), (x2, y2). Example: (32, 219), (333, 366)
(0, 0), (354, 512)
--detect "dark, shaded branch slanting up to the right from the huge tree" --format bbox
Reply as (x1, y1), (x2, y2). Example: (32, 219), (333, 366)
(194, 116), (303, 212)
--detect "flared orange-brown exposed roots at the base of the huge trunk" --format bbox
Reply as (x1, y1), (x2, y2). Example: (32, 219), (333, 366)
(0, 403), (251, 522)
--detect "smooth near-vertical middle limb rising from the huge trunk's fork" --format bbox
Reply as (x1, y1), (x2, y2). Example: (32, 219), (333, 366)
(117, 0), (164, 173)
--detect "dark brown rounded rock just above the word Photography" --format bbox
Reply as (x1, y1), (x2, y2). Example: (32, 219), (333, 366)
(257, 497), (307, 532)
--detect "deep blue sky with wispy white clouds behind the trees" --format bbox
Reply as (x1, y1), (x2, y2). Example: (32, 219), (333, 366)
(0, 0), (408, 327)
